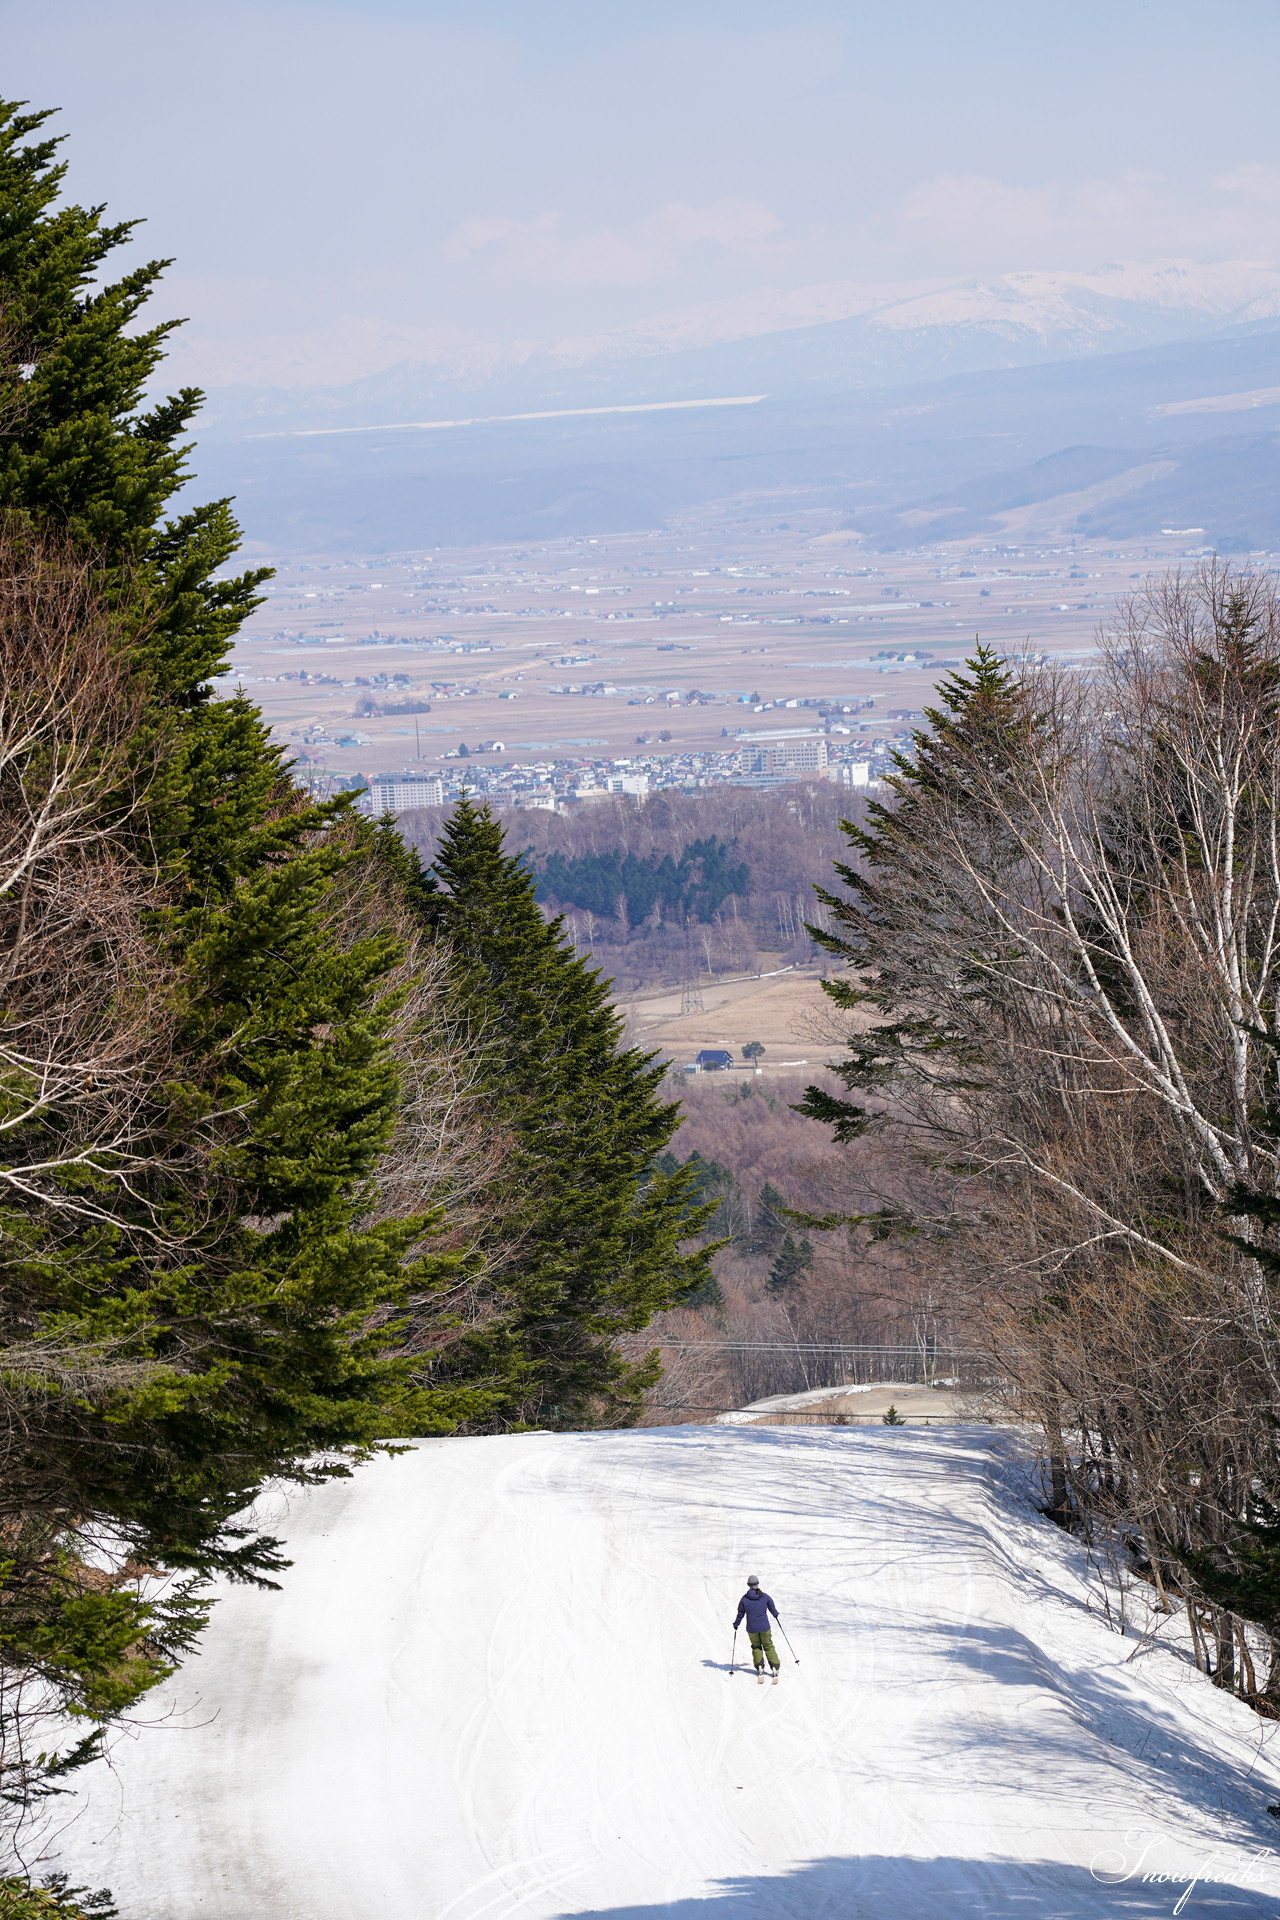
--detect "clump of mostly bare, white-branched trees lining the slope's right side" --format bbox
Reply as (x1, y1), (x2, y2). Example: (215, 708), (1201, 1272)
(814, 564), (1280, 1693)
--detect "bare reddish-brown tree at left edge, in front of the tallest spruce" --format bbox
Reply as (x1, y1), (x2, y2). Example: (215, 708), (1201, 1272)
(0, 530), (181, 1215)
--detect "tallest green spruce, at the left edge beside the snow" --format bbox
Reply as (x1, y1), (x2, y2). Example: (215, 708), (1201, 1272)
(0, 104), (486, 1797)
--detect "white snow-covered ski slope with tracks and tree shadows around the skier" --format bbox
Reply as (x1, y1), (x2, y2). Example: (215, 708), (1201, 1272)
(63, 1427), (1280, 1920)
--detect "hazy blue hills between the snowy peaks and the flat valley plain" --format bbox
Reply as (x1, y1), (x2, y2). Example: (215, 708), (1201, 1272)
(189, 323), (1280, 557)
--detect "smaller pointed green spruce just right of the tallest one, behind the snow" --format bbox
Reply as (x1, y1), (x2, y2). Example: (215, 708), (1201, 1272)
(420, 799), (712, 1427)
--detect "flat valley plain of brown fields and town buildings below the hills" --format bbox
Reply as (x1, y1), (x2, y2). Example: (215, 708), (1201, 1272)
(230, 511), (1228, 812)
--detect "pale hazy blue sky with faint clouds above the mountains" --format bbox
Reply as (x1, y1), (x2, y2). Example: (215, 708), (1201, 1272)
(4, 0), (1280, 384)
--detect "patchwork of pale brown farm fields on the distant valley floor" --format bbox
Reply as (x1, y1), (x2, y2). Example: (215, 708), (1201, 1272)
(214, 524), (1174, 774)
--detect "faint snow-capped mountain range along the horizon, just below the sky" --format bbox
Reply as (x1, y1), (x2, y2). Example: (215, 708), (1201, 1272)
(189, 261), (1280, 432)
